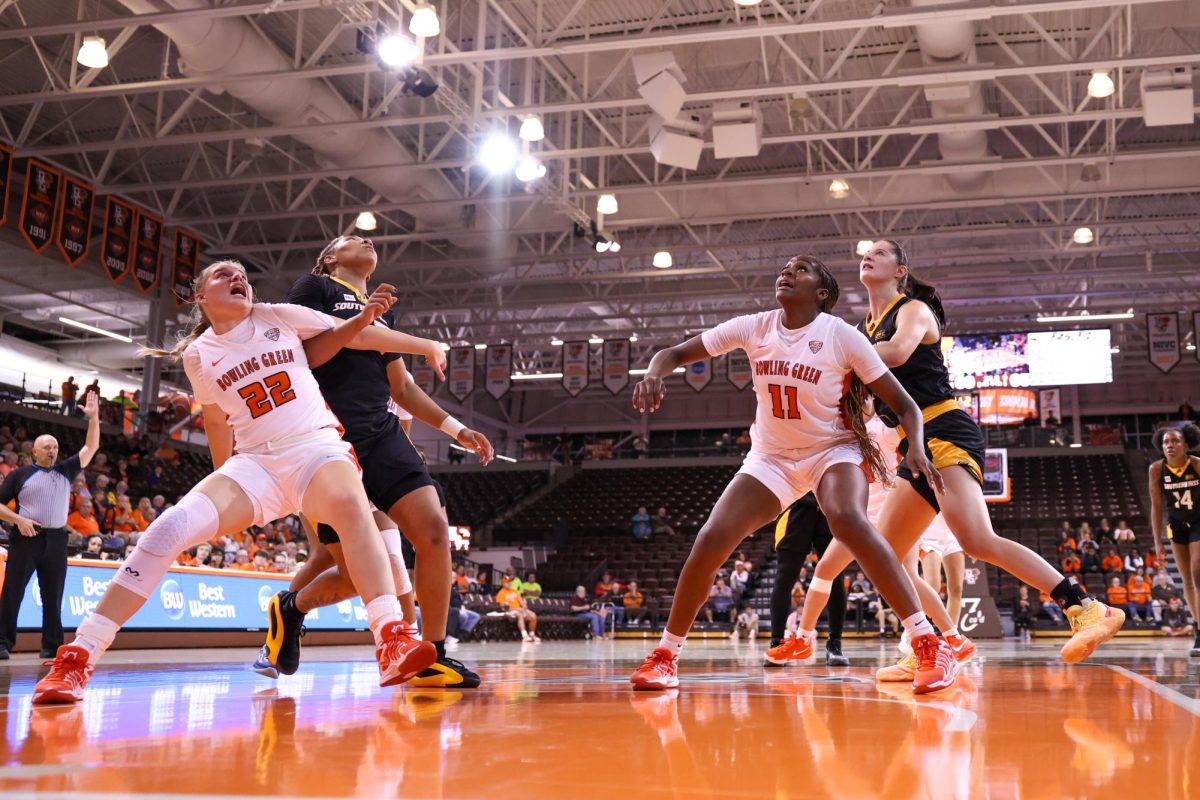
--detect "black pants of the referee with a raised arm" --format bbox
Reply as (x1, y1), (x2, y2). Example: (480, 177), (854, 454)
(0, 528), (67, 651)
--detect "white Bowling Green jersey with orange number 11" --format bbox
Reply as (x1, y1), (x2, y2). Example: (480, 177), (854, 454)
(702, 308), (888, 458)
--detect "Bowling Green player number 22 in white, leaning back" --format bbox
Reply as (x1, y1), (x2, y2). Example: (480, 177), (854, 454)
(34, 261), (445, 704)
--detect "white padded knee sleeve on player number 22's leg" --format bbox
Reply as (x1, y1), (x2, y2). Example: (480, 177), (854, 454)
(113, 492), (220, 597)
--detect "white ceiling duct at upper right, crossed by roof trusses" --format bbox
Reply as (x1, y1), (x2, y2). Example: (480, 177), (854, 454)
(910, 0), (988, 192)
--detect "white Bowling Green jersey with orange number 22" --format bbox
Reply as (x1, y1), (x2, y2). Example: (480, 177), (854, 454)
(184, 303), (338, 451)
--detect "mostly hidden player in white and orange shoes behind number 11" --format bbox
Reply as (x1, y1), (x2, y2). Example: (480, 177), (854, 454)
(767, 416), (976, 680)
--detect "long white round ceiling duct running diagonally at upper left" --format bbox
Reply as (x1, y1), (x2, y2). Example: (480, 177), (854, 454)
(111, 0), (494, 249)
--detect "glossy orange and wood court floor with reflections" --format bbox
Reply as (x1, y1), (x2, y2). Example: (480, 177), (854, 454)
(0, 643), (1200, 800)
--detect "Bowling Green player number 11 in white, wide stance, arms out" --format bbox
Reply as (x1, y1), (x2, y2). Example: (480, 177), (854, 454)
(630, 255), (958, 692)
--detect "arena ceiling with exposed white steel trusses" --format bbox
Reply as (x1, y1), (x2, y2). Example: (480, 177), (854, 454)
(0, 0), (1200, 381)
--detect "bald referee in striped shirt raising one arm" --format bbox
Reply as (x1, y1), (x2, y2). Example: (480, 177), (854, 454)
(0, 392), (100, 660)
